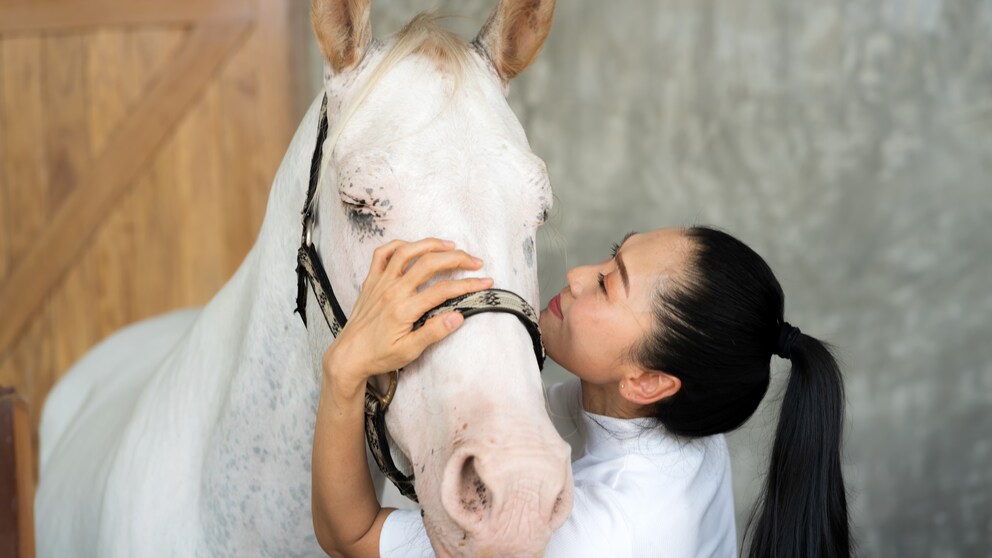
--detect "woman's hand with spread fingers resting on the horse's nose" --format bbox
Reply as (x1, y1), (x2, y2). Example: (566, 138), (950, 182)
(323, 238), (493, 397)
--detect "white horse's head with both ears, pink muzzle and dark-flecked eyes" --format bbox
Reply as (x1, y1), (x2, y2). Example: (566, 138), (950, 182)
(313, 0), (572, 555)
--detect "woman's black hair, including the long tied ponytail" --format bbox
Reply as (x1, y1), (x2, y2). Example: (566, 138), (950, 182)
(634, 227), (851, 558)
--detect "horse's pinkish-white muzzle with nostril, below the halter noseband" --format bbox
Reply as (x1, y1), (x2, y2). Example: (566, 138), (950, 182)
(387, 314), (572, 556)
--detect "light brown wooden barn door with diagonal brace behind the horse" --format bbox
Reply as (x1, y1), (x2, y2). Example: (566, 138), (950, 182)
(0, 0), (312, 482)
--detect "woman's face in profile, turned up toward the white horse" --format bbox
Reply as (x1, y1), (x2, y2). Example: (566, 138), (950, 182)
(541, 228), (688, 385)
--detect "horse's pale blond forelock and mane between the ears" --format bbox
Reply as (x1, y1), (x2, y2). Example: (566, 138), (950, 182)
(312, 12), (470, 211)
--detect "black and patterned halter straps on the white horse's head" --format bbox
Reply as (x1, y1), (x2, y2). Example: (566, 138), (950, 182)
(296, 94), (545, 502)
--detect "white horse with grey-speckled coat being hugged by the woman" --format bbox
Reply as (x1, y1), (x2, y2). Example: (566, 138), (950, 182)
(36, 0), (571, 558)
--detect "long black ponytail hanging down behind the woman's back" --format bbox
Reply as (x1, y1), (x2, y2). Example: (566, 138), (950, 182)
(745, 334), (851, 558)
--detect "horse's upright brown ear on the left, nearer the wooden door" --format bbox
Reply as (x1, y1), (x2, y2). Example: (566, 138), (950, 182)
(310, 0), (372, 73)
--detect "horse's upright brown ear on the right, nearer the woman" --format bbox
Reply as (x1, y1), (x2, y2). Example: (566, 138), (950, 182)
(476, 0), (555, 81)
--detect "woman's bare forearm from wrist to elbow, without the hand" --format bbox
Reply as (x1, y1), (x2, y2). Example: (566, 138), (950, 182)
(312, 371), (392, 558)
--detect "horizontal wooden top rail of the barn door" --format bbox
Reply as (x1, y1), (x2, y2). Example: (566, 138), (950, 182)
(0, 0), (253, 35)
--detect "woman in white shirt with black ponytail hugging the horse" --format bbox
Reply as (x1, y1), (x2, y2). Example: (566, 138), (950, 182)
(313, 227), (851, 557)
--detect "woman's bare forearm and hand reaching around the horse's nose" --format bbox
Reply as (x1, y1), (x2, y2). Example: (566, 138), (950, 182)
(311, 238), (482, 558)
